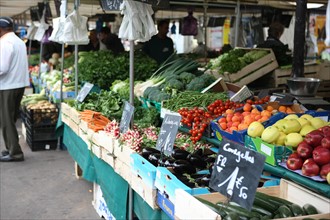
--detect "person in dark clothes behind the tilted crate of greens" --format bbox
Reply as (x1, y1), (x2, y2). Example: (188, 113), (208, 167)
(258, 22), (292, 66)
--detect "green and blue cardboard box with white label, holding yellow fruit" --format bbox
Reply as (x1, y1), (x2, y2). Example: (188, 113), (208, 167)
(244, 135), (293, 166)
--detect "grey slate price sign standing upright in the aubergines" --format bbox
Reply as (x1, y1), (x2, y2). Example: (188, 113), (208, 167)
(156, 113), (181, 156)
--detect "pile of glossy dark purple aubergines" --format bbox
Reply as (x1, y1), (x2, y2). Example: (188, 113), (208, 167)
(141, 147), (217, 188)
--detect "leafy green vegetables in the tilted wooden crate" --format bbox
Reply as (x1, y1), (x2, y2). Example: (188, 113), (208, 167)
(208, 49), (269, 74)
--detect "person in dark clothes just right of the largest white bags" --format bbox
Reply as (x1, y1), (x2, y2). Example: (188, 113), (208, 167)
(143, 20), (174, 64)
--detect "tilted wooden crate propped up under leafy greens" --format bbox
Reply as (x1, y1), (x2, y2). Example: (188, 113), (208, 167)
(223, 48), (278, 86)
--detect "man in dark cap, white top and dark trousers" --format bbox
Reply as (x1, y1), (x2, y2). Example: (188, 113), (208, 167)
(0, 17), (29, 162)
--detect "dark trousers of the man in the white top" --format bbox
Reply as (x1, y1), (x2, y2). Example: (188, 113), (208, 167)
(0, 88), (24, 156)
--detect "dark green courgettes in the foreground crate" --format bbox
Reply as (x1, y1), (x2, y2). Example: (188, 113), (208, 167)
(196, 191), (318, 219)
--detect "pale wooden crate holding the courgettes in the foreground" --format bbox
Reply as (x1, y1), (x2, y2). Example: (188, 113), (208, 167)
(174, 179), (330, 220)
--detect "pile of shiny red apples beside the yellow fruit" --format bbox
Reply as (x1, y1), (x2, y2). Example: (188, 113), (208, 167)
(286, 125), (330, 179)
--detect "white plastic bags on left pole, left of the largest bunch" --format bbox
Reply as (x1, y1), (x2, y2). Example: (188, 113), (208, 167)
(59, 10), (89, 45)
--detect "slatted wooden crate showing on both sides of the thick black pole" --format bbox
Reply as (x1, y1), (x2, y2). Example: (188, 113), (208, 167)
(270, 63), (321, 88)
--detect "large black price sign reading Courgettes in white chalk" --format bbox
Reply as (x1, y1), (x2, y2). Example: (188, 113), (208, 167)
(209, 139), (266, 210)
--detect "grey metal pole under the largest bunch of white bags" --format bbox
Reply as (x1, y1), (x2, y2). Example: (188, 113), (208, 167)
(128, 40), (134, 220)
